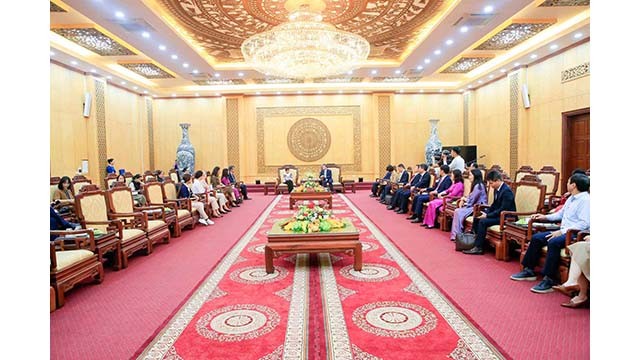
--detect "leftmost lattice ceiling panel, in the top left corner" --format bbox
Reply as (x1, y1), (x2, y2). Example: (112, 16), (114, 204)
(51, 27), (136, 56)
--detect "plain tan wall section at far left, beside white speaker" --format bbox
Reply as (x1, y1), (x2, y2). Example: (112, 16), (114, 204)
(49, 64), (90, 176)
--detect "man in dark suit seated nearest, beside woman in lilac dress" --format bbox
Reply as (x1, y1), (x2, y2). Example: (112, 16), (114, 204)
(462, 170), (516, 255)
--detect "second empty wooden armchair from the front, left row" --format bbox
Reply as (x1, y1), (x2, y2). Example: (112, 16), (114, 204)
(76, 190), (153, 269)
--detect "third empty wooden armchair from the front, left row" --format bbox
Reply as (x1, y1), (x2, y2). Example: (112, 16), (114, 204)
(107, 186), (171, 248)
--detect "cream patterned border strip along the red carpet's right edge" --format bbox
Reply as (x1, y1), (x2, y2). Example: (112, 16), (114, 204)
(339, 194), (505, 359)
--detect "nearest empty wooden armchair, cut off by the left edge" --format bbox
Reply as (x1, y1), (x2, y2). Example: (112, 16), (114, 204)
(49, 230), (104, 307)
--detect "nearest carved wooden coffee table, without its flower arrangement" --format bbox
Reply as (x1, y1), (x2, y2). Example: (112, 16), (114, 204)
(264, 220), (362, 274)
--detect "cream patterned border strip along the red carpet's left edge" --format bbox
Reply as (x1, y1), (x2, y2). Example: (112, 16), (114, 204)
(138, 195), (282, 360)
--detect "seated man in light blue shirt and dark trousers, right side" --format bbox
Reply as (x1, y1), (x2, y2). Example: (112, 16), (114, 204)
(511, 174), (591, 294)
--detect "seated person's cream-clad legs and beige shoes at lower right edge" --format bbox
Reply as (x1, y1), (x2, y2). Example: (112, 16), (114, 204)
(553, 235), (591, 308)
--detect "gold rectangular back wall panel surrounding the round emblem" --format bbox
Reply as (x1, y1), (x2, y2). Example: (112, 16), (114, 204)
(256, 106), (362, 174)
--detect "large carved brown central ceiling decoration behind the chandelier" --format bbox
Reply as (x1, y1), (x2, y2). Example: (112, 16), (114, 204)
(155, 0), (447, 63)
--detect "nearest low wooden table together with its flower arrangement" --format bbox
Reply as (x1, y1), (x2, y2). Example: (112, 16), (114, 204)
(264, 206), (362, 274)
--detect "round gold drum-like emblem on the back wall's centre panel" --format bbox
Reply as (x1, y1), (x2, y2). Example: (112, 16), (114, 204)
(287, 118), (331, 162)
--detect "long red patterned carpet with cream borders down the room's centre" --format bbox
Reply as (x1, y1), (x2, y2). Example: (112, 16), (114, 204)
(140, 196), (502, 359)
